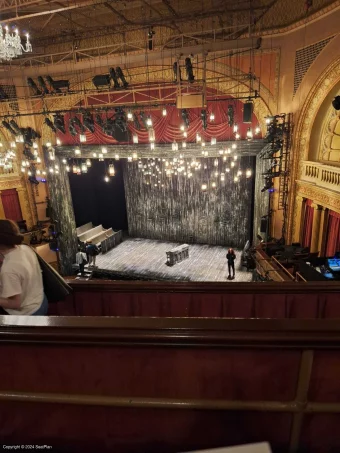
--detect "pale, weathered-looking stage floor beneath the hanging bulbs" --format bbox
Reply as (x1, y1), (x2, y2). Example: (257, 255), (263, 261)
(96, 238), (252, 282)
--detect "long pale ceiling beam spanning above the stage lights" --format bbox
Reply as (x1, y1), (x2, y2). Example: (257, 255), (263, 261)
(0, 38), (261, 78)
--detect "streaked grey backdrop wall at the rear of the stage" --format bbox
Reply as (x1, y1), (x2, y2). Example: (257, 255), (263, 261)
(124, 157), (254, 248)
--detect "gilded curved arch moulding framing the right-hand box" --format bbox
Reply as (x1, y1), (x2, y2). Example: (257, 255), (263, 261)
(287, 58), (340, 242)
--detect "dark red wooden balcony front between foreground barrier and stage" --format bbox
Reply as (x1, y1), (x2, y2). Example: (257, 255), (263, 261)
(50, 280), (340, 319)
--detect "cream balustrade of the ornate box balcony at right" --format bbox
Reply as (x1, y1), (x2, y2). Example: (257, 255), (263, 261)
(301, 161), (340, 191)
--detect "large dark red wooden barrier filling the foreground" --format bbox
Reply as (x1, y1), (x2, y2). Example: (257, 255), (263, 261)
(0, 316), (340, 453)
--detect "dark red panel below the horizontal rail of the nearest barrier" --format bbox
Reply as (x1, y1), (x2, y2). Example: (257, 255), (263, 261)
(0, 402), (291, 453)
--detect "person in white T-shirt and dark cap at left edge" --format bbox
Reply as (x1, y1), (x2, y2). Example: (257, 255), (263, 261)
(0, 220), (48, 316)
